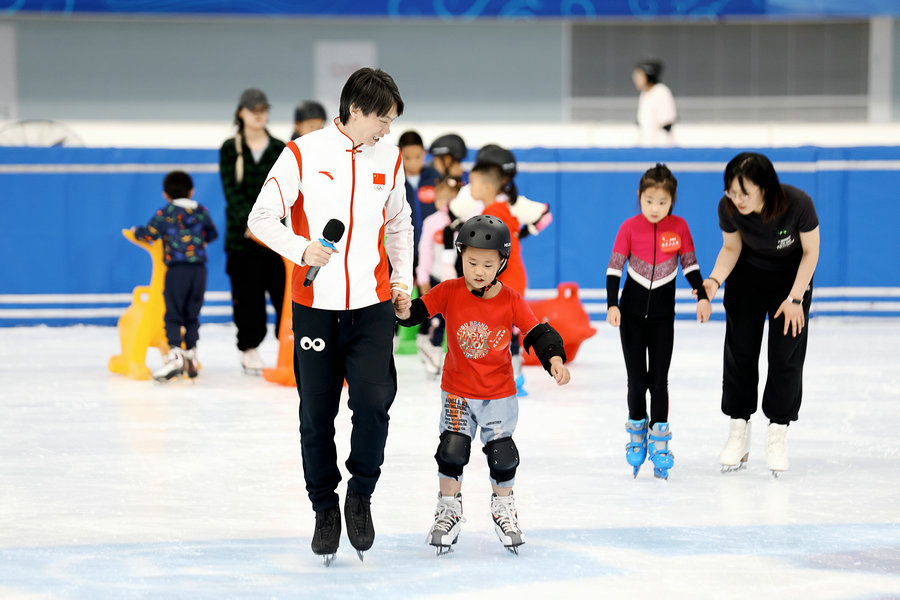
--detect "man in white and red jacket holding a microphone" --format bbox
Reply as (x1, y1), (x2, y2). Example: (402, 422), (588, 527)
(247, 68), (413, 565)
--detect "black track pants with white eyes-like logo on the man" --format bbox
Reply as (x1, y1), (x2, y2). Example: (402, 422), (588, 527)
(293, 301), (397, 511)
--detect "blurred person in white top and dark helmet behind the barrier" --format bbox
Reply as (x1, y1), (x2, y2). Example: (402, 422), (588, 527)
(631, 60), (678, 146)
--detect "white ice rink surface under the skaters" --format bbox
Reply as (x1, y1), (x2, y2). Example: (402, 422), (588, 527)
(0, 318), (900, 600)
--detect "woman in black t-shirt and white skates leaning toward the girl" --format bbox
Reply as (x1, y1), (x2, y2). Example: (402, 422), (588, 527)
(703, 152), (819, 476)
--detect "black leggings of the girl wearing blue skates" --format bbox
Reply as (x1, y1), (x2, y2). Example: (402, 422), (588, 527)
(619, 311), (675, 427)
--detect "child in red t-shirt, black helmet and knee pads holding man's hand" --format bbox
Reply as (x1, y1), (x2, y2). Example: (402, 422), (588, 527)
(398, 215), (569, 554)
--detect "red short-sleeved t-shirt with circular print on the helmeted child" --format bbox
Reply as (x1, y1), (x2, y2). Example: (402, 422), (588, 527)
(422, 277), (538, 400)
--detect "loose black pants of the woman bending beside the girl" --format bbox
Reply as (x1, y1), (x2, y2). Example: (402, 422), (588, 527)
(722, 261), (812, 425)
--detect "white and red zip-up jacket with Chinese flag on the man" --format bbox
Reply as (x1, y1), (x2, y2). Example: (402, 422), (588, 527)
(247, 123), (413, 310)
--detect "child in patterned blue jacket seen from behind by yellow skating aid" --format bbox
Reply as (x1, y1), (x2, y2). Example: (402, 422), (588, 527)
(133, 171), (219, 381)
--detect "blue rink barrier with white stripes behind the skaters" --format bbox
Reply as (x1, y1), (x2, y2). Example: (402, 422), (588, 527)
(0, 147), (900, 326)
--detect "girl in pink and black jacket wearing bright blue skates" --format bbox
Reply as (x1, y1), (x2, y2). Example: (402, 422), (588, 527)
(606, 164), (712, 479)
